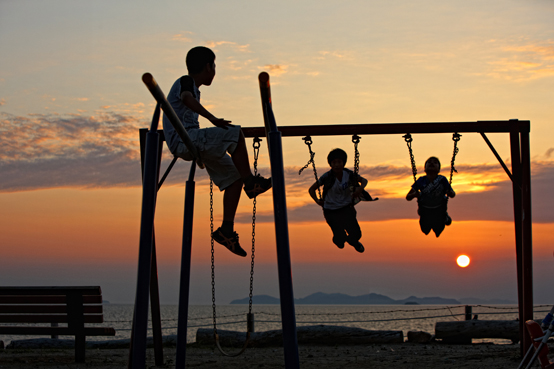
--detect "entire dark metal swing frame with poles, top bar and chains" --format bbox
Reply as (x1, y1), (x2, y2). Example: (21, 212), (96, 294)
(129, 72), (533, 369)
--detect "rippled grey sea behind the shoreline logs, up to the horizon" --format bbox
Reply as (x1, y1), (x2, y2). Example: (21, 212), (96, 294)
(0, 304), (551, 345)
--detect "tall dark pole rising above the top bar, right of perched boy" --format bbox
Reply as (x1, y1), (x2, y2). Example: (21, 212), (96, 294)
(259, 72), (300, 369)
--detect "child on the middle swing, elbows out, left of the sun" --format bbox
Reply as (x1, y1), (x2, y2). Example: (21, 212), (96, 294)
(308, 149), (372, 252)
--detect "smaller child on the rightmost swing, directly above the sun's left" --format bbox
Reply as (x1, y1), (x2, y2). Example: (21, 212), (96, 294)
(406, 156), (456, 237)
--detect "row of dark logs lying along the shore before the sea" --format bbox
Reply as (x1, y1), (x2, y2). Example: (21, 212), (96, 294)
(6, 320), (519, 349)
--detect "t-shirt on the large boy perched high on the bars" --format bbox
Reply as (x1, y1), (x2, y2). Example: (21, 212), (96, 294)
(163, 76), (200, 152)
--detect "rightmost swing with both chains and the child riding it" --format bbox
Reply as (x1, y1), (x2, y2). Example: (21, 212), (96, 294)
(402, 132), (462, 237)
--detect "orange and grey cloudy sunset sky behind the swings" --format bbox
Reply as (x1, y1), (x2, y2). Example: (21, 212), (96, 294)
(0, 0), (554, 304)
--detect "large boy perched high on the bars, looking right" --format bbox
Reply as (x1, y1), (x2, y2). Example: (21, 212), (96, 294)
(163, 46), (271, 257)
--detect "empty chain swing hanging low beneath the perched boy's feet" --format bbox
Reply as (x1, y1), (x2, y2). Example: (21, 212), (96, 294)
(210, 137), (262, 357)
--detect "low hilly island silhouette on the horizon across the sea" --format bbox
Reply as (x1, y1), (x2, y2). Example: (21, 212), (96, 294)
(227, 292), (515, 305)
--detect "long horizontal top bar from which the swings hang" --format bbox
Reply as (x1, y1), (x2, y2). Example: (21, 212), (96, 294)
(242, 119), (531, 137)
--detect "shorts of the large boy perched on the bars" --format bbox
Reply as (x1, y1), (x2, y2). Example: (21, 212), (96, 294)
(173, 126), (241, 191)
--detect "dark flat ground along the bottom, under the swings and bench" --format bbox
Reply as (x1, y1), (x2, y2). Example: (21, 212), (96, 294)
(0, 343), (553, 369)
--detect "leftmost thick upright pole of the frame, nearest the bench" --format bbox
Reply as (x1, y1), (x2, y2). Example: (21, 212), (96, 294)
(129, 104), (160, 369)
